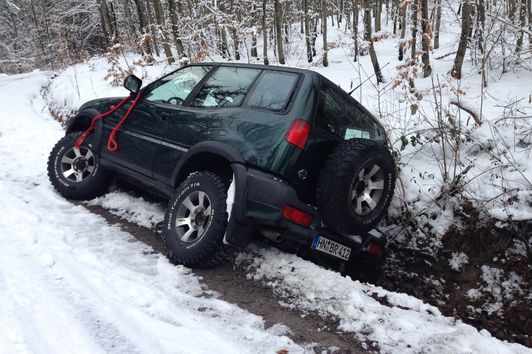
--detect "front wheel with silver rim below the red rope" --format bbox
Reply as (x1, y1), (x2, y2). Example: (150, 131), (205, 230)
(48, 132), (113, 200)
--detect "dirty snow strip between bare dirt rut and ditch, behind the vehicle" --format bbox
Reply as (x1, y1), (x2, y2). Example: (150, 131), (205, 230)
(81, 185), (532, 354)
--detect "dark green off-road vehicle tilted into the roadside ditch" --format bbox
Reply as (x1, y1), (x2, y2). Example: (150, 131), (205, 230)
(48, 63), (395, 267)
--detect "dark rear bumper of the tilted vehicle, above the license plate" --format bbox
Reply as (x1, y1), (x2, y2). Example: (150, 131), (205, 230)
(225, 163), (386, 255)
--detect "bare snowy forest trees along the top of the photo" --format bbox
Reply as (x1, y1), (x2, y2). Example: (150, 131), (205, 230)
(0, 0), (532, 81)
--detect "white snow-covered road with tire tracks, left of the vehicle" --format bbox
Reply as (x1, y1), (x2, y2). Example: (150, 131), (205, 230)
(0, 72), (305, 353)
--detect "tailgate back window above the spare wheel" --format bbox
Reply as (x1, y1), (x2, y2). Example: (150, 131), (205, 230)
(316, 83), (385, 140)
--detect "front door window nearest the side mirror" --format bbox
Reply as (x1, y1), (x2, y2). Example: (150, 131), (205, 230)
(145, 65), (212, 106)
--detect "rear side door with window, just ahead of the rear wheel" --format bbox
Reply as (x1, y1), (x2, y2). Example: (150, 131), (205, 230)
(153, 66), (261, 183)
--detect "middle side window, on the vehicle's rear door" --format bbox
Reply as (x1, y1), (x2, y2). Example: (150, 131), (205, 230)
(190, 67), (260, 108)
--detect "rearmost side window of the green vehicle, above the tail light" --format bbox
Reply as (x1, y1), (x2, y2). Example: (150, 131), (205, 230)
(247, 71), (298, 111)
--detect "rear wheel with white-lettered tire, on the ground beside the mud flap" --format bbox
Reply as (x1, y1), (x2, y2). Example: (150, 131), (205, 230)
(163, 171), (231, 268)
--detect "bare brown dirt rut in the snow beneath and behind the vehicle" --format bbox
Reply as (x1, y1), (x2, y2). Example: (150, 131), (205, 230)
(82, 204), (375, 353)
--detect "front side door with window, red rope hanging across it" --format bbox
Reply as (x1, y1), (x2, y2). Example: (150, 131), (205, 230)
(102, 65), (211, 177)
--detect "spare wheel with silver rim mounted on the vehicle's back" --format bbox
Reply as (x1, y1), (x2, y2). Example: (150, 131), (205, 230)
(317, 139), (396, 234)
